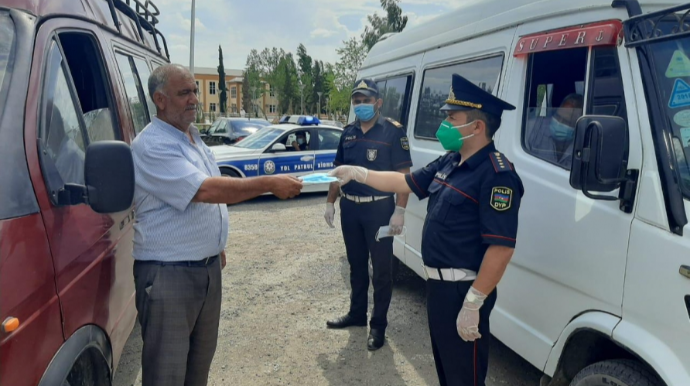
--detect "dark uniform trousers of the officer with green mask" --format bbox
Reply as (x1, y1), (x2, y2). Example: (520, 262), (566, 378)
(427, 279), (497, 386)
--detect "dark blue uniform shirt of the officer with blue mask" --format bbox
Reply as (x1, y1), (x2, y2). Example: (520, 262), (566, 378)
(334, 116), (412, 196)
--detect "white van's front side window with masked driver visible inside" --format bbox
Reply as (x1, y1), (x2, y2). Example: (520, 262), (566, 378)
(522, 47), (627, 170)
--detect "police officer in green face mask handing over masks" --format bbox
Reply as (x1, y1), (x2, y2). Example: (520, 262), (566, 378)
(330, 74), (523, 386)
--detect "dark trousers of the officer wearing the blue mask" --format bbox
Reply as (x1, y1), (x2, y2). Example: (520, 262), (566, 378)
(340, 197), (395, 330)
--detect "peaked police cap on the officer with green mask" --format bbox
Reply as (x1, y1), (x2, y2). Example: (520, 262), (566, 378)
(441, 74), (515, 119)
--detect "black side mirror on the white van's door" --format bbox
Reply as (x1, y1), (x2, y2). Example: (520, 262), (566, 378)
(570, 115), (637, 212)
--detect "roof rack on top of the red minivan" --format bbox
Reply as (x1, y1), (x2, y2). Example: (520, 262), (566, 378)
(106, 0), (170, 59)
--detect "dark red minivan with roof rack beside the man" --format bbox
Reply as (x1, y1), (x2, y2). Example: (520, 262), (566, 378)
(0, 0), (169, 386)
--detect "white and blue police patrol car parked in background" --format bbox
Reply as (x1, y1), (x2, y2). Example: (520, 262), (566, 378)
(211, 115), (343, 192)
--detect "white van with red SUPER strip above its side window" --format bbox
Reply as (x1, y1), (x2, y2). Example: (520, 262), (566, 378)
(351, 0), (690, 386)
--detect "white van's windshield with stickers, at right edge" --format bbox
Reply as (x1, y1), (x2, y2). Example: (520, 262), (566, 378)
(649, 15), (690, 196)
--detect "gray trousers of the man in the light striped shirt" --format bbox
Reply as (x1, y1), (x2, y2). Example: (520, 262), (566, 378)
(134, 258), (222, 386)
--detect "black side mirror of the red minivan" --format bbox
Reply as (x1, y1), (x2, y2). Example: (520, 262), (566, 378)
(84, 141), (134, 213)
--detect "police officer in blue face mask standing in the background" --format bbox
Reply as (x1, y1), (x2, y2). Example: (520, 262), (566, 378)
(324, 79), (412, 351)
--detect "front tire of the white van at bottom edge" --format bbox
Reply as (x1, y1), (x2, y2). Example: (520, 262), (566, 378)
(570, 359), (664, 386)
